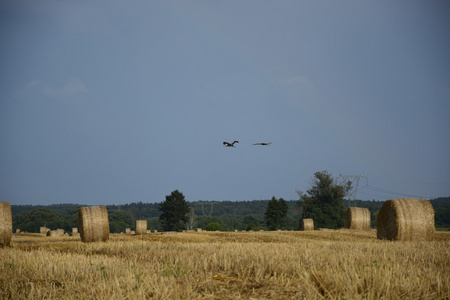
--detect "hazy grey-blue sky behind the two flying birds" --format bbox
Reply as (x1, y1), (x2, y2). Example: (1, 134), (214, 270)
(0, 0), (450, 205)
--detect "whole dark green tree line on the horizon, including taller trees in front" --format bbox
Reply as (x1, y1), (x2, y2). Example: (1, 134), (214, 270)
(11, 171), (450, 233)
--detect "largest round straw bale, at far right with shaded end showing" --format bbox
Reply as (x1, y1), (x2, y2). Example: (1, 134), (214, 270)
(377, 198), (434, 241)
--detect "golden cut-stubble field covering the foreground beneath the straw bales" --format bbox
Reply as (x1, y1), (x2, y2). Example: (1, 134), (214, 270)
(0, 230), (450, 300)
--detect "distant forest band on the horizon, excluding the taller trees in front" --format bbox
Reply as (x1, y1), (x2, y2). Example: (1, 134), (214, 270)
(11, 197), (450, 233)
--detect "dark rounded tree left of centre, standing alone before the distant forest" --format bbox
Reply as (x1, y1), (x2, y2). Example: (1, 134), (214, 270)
(159, 190), (190, 231)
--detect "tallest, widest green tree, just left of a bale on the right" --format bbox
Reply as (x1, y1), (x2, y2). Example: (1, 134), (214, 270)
(299, 171), (351, 229)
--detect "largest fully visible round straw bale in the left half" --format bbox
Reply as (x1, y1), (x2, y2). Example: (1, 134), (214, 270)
(78, 206), (109, 242)
